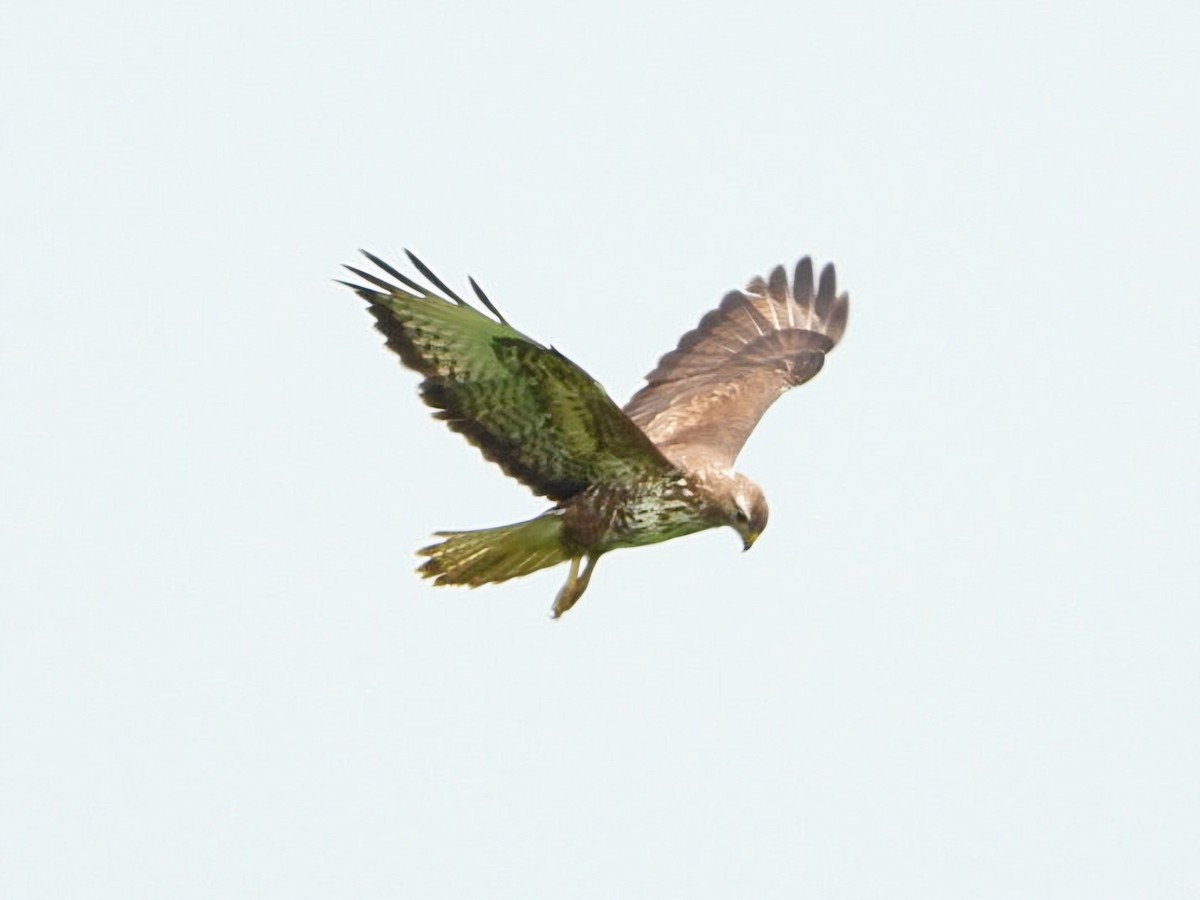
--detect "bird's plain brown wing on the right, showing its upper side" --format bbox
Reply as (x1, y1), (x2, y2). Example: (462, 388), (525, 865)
(625, 257), (850, 468)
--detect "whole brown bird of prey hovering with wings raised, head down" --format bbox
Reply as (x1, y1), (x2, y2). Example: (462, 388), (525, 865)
(341, 251), (850, 618)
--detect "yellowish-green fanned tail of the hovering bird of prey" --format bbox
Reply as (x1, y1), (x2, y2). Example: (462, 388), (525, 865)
(418, 514), (570, 587)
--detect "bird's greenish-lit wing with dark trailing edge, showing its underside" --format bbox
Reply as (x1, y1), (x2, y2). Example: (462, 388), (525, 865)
(342, 251), (674, 500)
